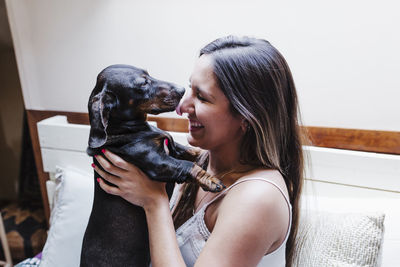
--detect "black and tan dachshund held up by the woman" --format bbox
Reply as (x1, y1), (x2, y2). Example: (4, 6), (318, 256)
(81, 65), (224, 267)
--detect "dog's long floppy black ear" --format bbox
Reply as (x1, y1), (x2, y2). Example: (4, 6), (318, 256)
(88, 89), (117, 148)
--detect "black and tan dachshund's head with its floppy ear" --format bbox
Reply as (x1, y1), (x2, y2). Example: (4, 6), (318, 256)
(88, 65), (185, 148)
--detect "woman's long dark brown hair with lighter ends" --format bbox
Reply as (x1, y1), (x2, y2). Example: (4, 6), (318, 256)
(173, 36), (303, 266)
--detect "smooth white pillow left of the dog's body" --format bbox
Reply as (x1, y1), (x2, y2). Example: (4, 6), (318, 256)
(40, 168), (94, 267)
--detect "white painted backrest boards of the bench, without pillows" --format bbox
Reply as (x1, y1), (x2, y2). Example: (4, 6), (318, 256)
(37, 116), (400, 267)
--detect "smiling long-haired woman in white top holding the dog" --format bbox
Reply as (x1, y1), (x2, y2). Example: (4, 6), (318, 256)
(96, 36), (303, 267)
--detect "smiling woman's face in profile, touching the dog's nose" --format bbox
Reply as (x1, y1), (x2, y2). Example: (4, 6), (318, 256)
(180, 55), (243, 151)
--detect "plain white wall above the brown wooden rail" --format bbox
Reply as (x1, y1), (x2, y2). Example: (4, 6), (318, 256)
(6, 0), (400, 131)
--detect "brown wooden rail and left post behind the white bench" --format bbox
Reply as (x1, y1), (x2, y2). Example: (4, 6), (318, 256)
(27, 110), (400, 225)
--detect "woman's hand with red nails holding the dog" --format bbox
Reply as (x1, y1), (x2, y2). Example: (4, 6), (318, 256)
(92, 150), (168, 213)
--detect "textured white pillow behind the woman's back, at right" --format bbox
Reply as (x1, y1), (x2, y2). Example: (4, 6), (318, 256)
(293, 210), (385, 267)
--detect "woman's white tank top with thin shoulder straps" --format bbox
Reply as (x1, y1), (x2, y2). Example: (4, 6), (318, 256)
(170, 178), (292, 267)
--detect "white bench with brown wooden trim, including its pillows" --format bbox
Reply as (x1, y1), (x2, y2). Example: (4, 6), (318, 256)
(15, 112), (400, 267)
